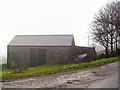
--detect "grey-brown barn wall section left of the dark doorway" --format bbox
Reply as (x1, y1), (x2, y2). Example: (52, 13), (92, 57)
(7, 47), (30, 68)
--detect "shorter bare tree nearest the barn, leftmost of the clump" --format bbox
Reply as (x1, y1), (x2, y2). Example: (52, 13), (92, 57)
(92, 22), (109, 54)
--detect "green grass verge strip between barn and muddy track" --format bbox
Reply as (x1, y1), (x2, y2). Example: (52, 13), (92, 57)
(0, 57), (120, 80)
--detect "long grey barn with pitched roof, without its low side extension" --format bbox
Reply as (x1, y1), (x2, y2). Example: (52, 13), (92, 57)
(7, 35), (75, 68)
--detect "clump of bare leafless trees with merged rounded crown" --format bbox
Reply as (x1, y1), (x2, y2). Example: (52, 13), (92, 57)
(92, 1), (120, 54)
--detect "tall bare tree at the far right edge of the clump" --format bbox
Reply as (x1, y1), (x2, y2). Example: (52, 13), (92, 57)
(103, 1), (120, 52)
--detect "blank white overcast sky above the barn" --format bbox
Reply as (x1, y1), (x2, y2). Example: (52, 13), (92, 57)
(0, 0), (112, 56)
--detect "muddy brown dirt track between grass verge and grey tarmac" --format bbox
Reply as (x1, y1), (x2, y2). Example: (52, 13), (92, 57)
(2, 62), (118, 88)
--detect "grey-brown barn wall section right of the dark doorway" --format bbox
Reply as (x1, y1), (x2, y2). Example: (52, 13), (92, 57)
(46, 47), (73, 64)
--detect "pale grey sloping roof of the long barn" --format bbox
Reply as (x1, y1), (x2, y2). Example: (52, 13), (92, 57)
(8, 35), (74, 46)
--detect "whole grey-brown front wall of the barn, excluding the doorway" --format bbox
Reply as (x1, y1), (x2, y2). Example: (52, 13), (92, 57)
(7, 46), (73, 68)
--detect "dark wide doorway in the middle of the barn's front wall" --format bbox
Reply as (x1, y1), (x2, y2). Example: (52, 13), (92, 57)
(30, 48), (47, 67)
